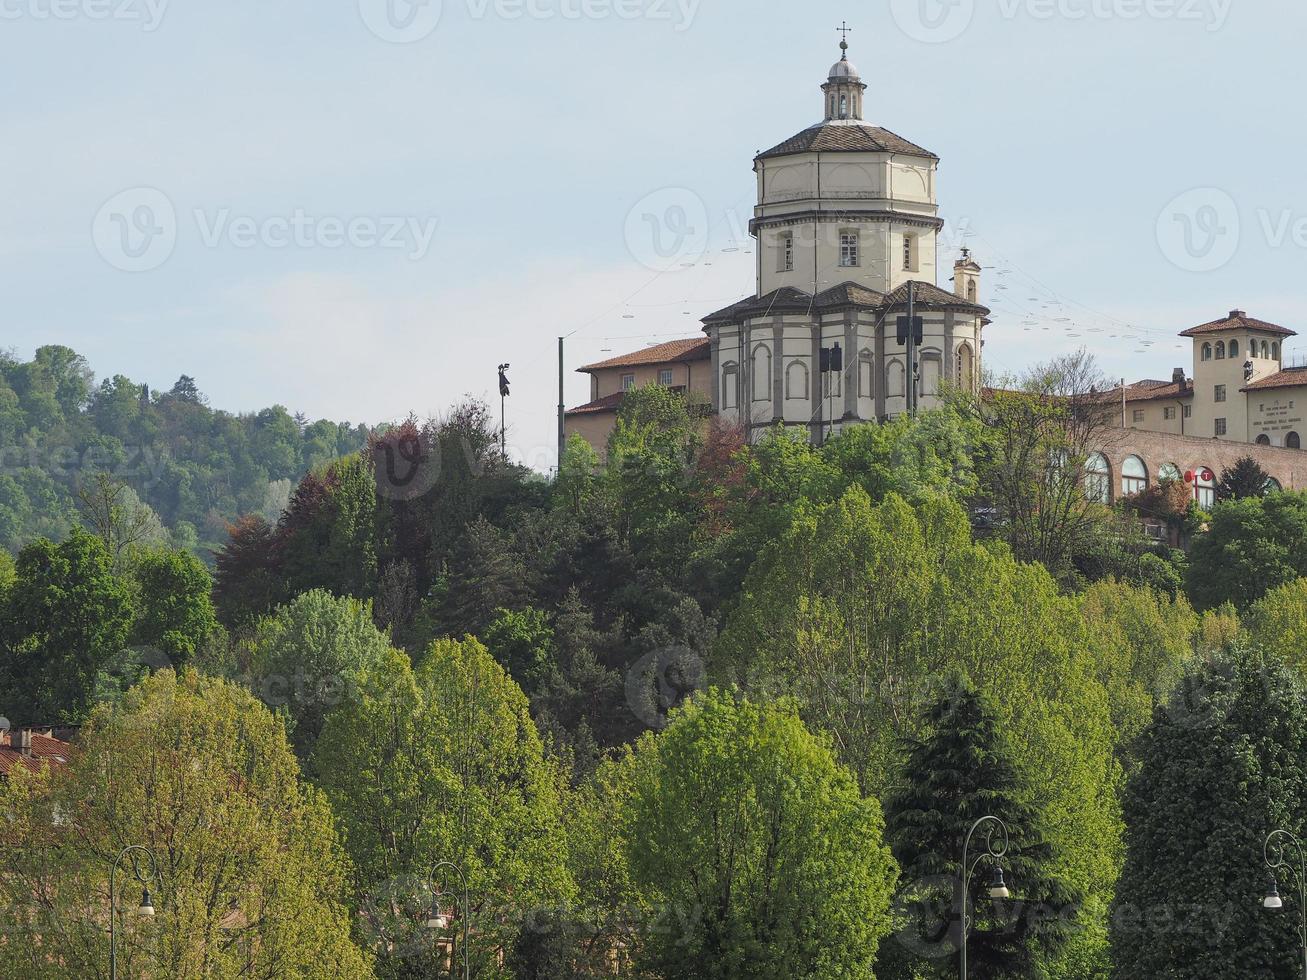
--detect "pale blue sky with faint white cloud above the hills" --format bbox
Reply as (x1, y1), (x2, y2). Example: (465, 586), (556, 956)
(0, 0), (1307, 469)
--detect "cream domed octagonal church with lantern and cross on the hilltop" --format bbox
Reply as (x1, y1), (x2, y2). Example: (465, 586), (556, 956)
(703, 38), (989, 442)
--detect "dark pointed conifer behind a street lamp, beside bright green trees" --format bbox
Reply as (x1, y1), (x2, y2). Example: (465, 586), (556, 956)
(877, 674), (1081, 980)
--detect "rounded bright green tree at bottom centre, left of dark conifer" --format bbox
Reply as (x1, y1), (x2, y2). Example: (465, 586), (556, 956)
(627, 691), (895, 980)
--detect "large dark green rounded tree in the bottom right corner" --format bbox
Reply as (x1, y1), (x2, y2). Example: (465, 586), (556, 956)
(1111, 651), (1307, 980)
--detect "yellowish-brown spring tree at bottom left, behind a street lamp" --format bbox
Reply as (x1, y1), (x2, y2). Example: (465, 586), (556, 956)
(0, 670), (372, 980)
